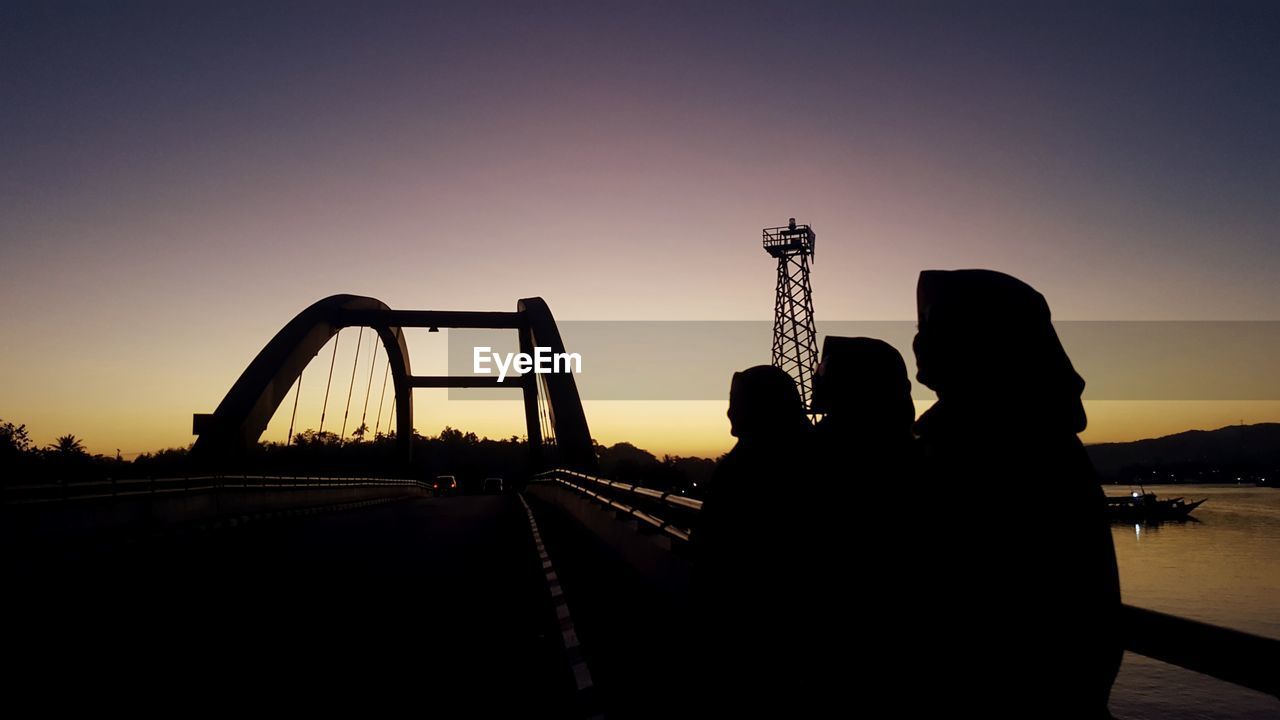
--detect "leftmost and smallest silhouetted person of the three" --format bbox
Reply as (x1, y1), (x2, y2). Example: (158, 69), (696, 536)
(692, 365), (813, 715)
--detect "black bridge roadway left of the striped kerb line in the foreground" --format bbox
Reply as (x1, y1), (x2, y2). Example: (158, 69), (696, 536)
(6, 496), (581, 717)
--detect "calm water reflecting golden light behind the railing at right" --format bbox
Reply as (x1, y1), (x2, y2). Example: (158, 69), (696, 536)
(1106, 486), (1280, 720)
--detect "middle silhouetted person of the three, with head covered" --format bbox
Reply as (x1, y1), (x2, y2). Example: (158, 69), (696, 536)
(801, 337), (920, 697)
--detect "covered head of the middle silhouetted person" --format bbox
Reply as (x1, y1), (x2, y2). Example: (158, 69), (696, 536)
(813, 337), (915, 436)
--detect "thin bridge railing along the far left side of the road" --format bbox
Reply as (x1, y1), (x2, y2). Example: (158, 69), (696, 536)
(0, 475), (430, 505)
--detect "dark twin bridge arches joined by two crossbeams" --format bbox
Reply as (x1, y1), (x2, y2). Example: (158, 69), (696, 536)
(192, 295), (595, 470)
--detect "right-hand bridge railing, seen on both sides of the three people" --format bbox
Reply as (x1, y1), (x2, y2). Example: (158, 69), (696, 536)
(535, 461), (1280, 697)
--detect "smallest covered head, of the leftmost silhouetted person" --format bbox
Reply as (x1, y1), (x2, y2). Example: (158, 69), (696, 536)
(728, 365), (810, 439)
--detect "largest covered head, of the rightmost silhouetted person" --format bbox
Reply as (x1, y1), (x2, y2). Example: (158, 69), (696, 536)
(914, 270), (1084, 432)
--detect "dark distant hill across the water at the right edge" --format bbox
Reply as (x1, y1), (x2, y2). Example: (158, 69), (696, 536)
(1085, 423), (1280, 482)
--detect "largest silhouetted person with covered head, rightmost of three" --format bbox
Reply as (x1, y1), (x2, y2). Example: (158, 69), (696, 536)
(915, 270), (1121, 719)
